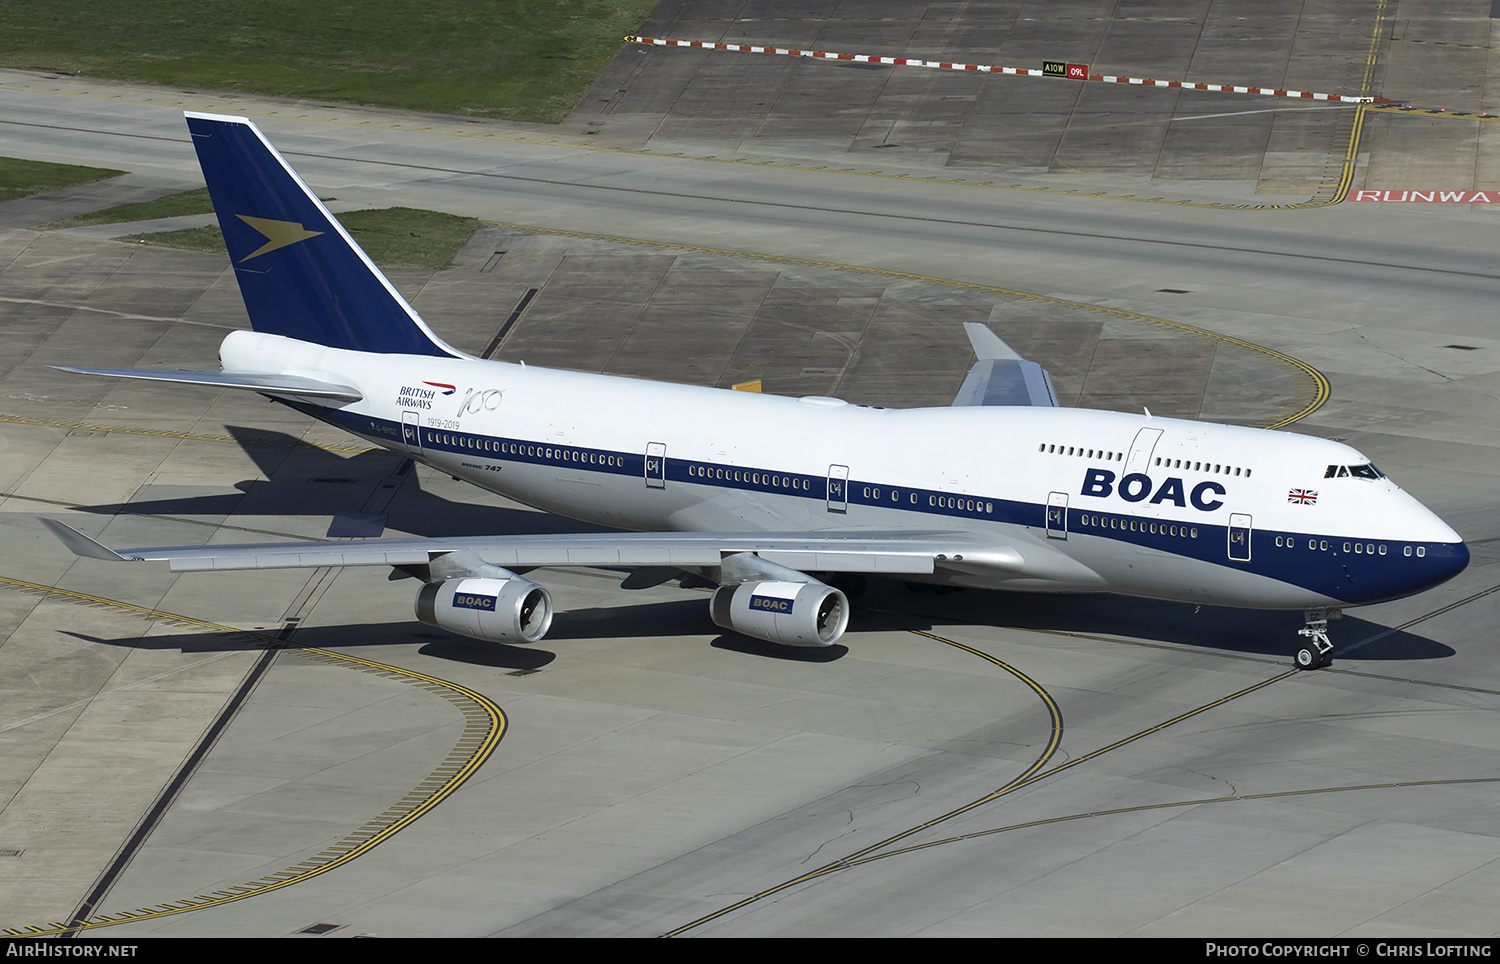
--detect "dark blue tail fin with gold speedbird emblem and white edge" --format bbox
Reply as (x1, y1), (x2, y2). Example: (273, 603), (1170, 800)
(186, 112), (461, 357)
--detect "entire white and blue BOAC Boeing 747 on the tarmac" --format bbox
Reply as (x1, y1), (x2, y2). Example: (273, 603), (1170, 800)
(47, 112), (1469, 669)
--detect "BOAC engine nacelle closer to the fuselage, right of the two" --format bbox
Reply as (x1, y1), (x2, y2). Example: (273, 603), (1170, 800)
(708, 582), (849, 646)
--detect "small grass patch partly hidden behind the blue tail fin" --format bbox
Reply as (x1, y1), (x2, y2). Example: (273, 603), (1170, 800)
(123, 207), (479, 270)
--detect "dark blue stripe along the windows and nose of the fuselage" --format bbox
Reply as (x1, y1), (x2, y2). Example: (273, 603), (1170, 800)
(285, 402), (1467, 604)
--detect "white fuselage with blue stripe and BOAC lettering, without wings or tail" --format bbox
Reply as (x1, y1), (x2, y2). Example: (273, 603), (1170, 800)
(221, 331), (1469, 609)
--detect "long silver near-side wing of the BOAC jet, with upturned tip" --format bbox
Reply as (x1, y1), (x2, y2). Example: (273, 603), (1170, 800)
(42, 519), (1026, 574)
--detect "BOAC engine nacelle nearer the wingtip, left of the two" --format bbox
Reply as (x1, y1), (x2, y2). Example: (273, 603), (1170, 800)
(416, 576), (552, 643)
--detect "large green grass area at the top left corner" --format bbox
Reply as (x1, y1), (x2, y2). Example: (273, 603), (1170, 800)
(0, 0), (656, 123)
